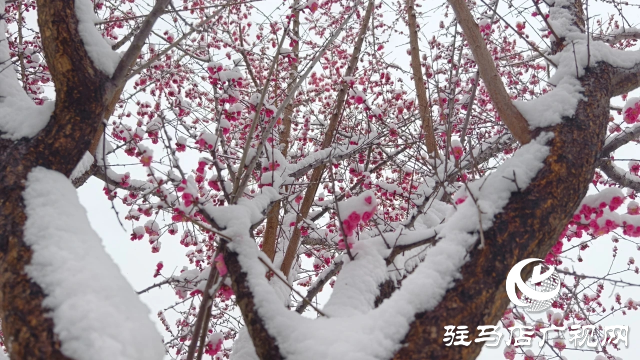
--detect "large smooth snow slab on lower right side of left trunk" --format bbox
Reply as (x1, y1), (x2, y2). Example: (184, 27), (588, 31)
(23, 167), (164, 360)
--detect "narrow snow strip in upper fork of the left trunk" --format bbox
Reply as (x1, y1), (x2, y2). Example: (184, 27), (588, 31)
(75, 0), (120, 76)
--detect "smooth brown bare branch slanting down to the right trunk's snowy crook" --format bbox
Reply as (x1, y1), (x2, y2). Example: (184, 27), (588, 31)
(449, 0), (531, 144)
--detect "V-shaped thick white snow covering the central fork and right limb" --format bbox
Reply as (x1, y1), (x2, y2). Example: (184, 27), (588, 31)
(226, 133), (553, 360)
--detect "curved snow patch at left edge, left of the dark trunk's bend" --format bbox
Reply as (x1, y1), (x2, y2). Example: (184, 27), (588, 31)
(0, 0), (54, 140)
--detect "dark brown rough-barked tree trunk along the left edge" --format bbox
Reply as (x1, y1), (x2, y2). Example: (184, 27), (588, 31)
(0, 0), (112, 360)
